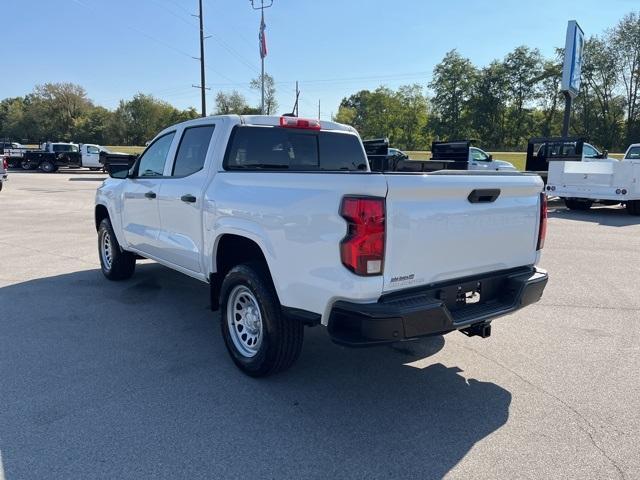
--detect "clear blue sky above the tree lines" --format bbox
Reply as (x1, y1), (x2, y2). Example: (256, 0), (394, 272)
(0, 0), (640, 118)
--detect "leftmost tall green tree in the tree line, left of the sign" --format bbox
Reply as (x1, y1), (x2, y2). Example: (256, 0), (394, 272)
(429, 50), (477, 139)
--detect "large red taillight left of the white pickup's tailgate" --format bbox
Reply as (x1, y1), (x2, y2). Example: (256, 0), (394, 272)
(340, 197), (385, 275)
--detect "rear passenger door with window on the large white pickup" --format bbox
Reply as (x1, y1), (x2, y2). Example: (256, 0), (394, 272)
(158, 121), (216, 273)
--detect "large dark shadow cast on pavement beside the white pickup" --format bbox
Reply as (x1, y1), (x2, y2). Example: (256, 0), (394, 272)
(0, 263), (511, 480)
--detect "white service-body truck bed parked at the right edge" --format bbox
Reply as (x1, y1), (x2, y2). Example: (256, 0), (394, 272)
(546, 155), (640, 215)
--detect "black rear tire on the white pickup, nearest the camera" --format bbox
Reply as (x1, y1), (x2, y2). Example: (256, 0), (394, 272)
(220, 263), (304, 377)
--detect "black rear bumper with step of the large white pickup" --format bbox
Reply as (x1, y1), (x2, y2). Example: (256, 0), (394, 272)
(328, 267), (548, 346)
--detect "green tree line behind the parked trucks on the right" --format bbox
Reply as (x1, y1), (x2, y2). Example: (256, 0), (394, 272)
(334, 13), (640, 151)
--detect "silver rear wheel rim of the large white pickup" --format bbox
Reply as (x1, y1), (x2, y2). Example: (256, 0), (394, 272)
(227, 285), (264, 358)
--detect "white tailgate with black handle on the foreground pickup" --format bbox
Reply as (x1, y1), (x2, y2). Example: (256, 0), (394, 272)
(384, 172), (542, 292)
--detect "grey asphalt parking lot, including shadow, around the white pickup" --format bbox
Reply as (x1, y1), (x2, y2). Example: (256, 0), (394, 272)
(0, 172), (640, 480)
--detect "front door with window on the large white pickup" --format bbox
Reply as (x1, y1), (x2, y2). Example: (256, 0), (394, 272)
(122, 132), (175, 256)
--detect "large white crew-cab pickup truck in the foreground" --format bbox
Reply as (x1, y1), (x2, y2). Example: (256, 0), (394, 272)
(95, 115), (547, 376)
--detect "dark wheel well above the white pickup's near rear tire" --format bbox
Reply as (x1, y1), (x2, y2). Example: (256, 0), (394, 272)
(210, 234), (273, 311)
